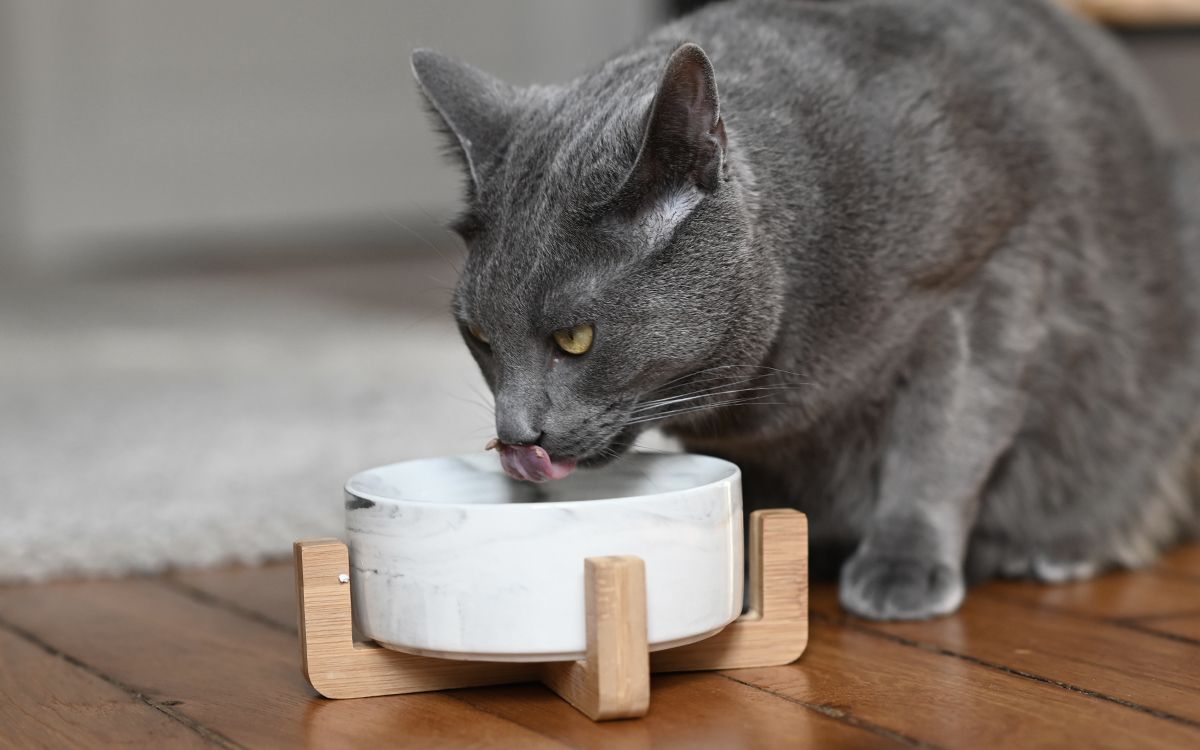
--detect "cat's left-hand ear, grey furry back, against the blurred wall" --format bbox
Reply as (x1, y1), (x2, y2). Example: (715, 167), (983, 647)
(413, 49), (516, 190)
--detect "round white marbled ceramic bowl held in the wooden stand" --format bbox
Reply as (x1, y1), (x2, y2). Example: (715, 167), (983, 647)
(346, 454), (743, 661)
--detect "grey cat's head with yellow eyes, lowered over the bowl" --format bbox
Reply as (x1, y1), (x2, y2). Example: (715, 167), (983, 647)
(413, 44), (775, 464)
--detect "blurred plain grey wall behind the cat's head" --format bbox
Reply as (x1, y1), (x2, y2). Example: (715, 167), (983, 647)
(0, 0), (665, 269)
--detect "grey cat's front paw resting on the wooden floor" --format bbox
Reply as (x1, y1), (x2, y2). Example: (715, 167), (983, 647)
(838, 552), (966, 619)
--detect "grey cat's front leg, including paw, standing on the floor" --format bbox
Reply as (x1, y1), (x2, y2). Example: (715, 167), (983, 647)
(839, 295), (1037, 619)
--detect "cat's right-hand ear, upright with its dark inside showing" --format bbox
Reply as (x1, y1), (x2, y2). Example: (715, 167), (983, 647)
(613, 42), (726, 210)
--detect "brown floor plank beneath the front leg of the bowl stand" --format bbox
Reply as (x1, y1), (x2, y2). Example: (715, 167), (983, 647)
(173, 565), (899, 750)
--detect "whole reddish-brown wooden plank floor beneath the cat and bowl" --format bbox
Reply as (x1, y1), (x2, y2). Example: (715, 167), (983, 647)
(0, 546), (1200, 749)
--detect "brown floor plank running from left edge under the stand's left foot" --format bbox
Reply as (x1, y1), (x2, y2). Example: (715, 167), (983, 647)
(0, 580), (564, 749)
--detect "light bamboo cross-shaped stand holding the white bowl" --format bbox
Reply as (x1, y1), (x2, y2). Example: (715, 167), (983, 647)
(294, 509), (809, 721)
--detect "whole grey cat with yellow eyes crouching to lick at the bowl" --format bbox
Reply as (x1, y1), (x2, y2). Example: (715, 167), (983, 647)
(413, 0), (1200, 618)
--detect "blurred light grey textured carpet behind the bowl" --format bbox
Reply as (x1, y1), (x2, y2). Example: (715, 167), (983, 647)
(0, 254), (501, 581)
